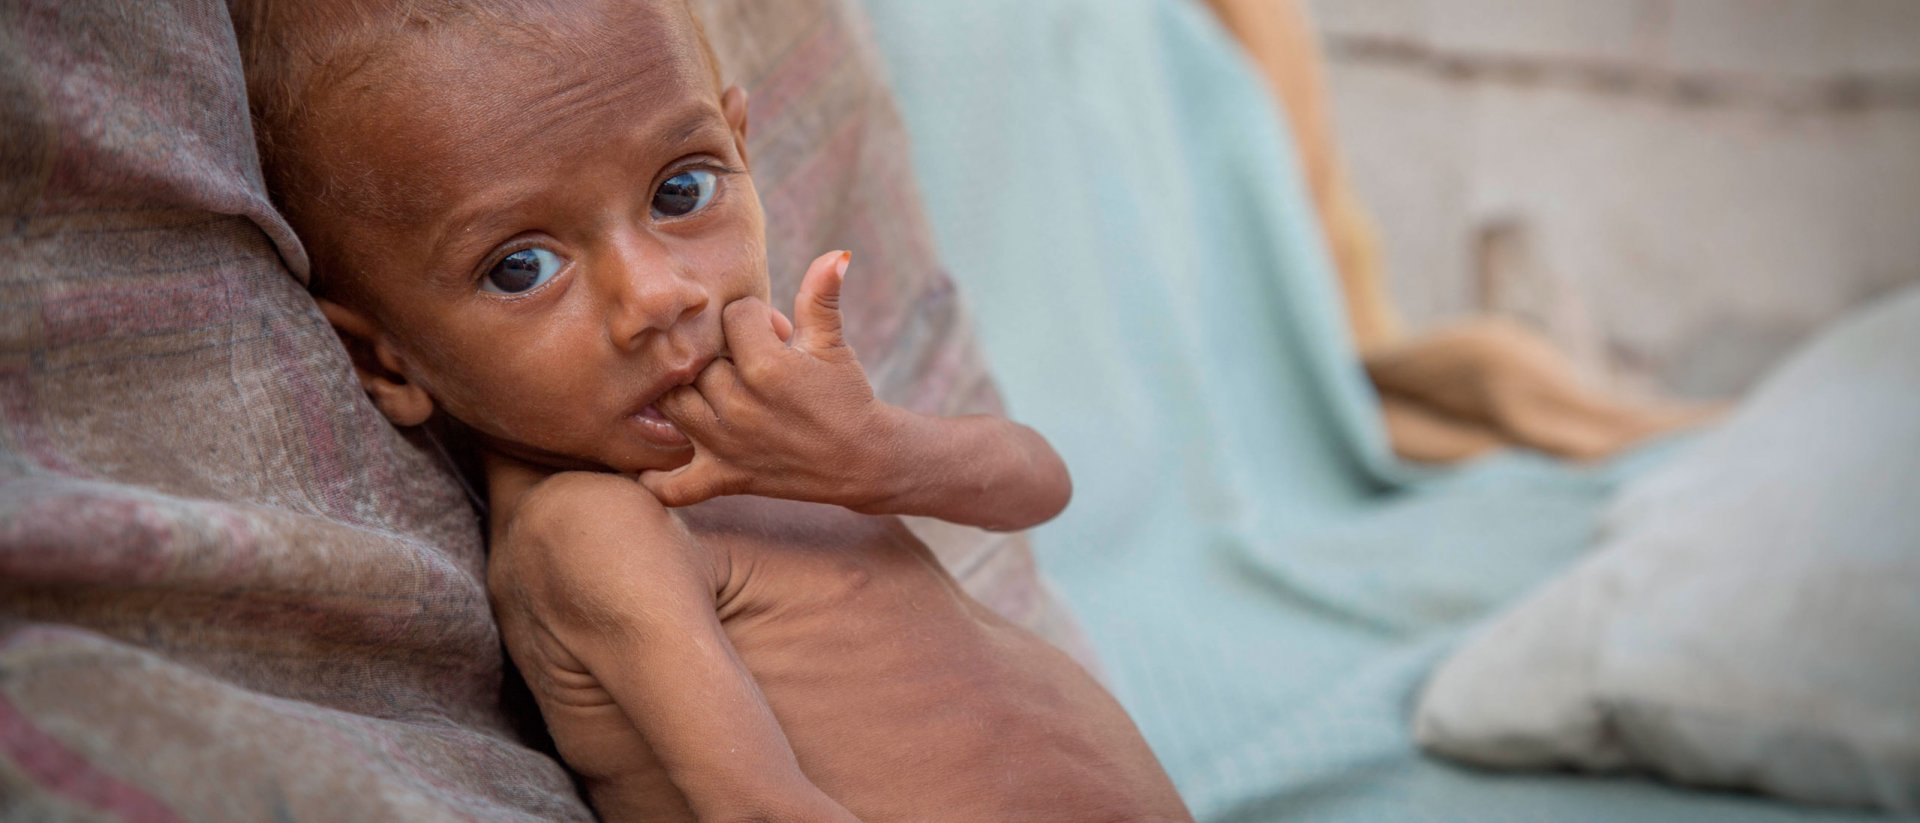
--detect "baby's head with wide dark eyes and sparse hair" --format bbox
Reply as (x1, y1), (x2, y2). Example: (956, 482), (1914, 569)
(234, 0), (768, 472)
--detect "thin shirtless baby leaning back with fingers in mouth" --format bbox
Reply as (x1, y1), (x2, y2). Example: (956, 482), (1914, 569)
(234, 0), (1190, 823)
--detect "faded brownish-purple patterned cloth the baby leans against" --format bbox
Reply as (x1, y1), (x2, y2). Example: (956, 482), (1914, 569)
(0, 0), (1075, 821)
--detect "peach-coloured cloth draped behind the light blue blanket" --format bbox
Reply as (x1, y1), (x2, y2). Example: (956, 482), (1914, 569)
(1208, 0), (1707, 462)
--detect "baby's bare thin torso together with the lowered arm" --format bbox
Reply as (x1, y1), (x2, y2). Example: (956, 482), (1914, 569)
(488, 472), (1187, 823)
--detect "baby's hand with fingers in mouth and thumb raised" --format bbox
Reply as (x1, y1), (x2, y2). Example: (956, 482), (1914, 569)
(639, 251), (895, 508)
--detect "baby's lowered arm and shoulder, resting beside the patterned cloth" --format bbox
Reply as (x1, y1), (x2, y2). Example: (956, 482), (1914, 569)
(488, 474), (854, 823)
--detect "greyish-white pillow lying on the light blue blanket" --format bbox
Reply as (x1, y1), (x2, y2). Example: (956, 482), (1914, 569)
(1415, 288), (1920, 813)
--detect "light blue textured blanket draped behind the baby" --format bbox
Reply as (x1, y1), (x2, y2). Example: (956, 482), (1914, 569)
(866, 0), (1873, 821)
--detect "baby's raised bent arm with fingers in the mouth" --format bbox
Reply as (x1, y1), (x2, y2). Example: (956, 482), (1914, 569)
(641, 253), (1071, 531)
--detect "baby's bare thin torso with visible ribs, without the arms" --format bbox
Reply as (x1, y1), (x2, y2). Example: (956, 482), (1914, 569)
(510, 499), (1185, 823)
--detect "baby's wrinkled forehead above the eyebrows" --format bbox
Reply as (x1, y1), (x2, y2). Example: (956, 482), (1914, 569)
(307, 0), (718, 223)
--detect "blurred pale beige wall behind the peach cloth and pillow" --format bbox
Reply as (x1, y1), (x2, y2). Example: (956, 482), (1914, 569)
(1309, 0), (1920, 397)
